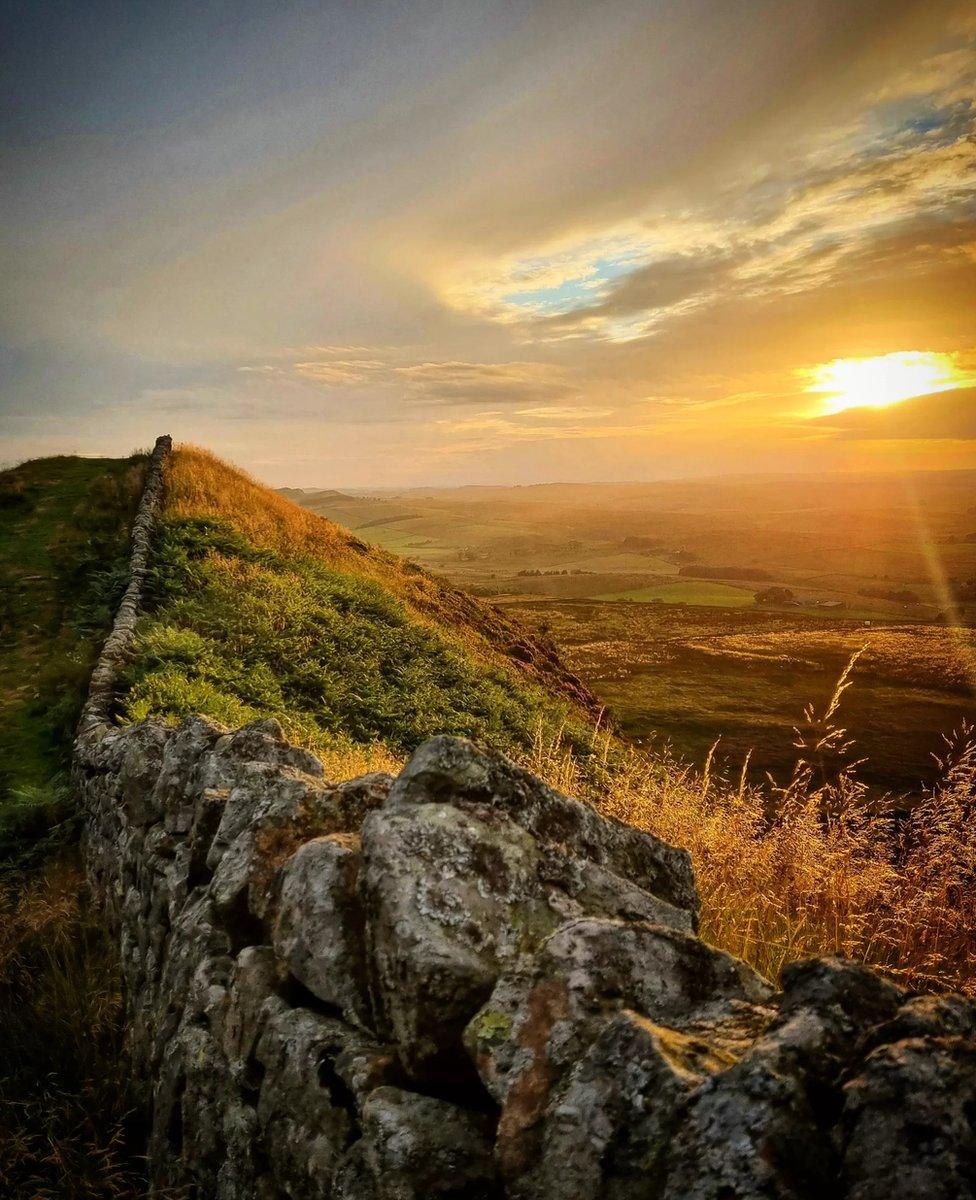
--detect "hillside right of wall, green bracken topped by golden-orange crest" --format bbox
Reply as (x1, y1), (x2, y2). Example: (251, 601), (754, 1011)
(122, 448), (595, 774)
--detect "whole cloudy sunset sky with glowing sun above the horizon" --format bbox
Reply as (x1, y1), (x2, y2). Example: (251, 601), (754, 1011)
(0, 0), (976, 487)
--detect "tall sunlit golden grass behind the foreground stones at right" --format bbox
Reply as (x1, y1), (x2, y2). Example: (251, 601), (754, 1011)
(523, 686), (976, 995)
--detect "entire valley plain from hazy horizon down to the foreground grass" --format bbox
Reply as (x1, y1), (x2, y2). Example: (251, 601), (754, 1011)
(289, 472), (976, 793)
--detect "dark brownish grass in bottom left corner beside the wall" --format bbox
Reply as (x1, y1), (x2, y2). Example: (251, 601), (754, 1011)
(0, 856), (150, 1200)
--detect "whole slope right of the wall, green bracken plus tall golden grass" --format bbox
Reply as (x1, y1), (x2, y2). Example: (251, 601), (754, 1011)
(131, 449), (976, 988)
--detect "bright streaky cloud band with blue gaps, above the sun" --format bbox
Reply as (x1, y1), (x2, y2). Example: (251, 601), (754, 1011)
(445, 31), (976, 341)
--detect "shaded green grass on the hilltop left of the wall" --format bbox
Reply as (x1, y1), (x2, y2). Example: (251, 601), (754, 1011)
(0, 457), (142, 860)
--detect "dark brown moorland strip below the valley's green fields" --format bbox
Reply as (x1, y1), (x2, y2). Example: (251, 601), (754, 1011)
(505, 598), (976, 794)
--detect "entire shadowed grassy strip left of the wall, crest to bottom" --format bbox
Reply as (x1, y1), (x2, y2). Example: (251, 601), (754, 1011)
(0, 457), (144, 1200)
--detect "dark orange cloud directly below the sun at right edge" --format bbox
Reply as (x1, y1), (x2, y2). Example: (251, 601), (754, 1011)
(810, 386), (976, 442)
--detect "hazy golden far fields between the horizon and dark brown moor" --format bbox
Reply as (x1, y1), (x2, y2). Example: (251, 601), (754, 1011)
(289, 472), (976, 623)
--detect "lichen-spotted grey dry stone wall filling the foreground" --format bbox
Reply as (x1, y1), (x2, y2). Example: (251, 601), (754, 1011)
(76, 436), (976, 1200)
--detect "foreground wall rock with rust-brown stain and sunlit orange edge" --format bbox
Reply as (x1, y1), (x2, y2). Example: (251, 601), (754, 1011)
(467, 919), (773, 1200)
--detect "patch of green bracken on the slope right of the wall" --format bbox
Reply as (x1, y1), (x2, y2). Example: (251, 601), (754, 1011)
(121, 516), (593, 755)
